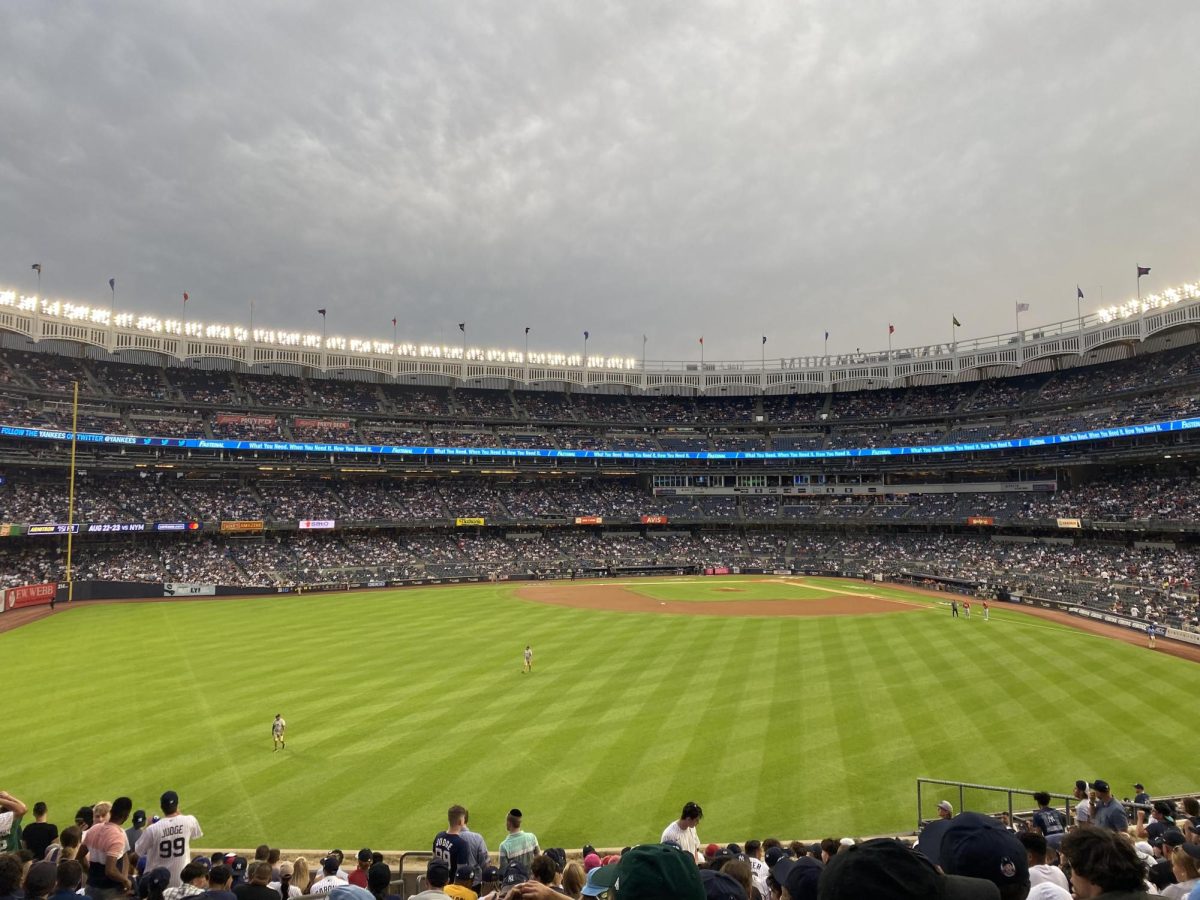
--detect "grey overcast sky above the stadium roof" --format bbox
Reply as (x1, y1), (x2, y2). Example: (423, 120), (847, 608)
(0, 0), (1200, 360)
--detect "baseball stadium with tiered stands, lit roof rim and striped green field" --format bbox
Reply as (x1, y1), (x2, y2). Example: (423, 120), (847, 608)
(0, 277), (1200, 897)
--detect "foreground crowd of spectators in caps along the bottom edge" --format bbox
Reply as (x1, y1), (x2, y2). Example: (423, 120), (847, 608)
(0, 782), (1200, 900)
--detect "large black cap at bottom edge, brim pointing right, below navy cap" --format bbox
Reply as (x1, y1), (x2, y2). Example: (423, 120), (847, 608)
(817, 838), (1000, 900)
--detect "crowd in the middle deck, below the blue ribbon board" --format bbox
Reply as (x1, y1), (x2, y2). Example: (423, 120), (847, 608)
(7, 469), (1200, 527)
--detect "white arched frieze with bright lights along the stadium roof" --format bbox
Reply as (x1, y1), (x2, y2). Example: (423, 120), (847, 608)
(0, 283), (1200, 395)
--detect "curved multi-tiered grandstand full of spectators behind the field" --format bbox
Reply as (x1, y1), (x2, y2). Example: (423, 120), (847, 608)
(0, 285), (1200, 892)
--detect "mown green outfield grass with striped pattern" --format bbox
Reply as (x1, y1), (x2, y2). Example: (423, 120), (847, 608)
(0, 580), (1196, 848)
